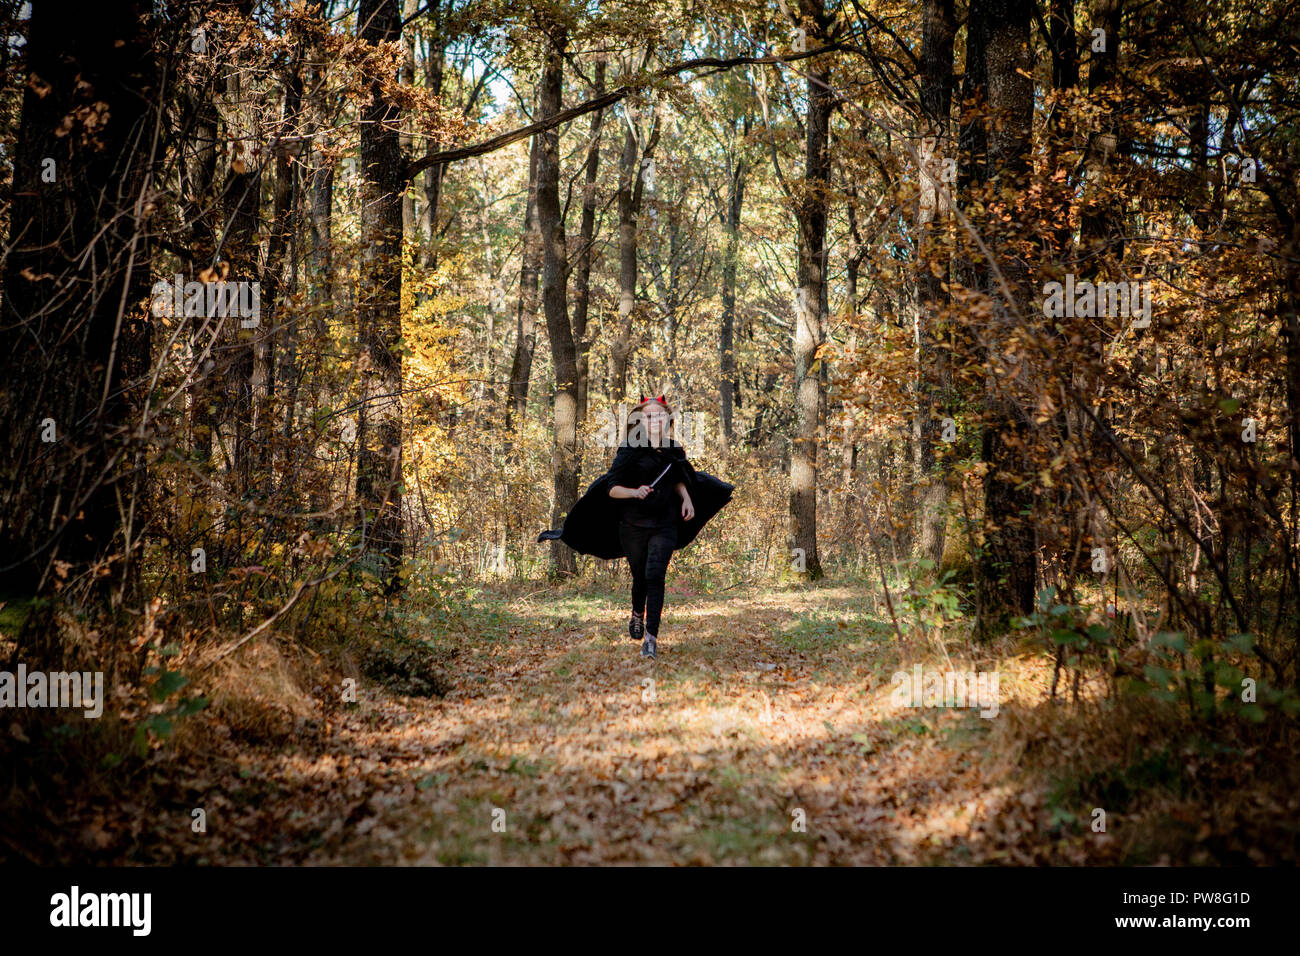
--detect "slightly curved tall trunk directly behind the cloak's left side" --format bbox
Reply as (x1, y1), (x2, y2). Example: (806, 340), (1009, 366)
(537, 26), (579, 574)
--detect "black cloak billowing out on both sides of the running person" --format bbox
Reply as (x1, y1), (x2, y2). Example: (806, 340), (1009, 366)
(537, 442), (735, 561)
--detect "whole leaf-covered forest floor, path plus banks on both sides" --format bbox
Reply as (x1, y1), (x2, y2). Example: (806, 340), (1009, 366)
(7, 581), (1297, 865)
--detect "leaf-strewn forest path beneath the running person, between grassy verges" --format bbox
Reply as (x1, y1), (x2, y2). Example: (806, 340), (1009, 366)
(308, 587), (1013, 864)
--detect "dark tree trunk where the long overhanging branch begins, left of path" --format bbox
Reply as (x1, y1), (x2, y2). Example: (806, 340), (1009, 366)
(356, 0), (406, 589)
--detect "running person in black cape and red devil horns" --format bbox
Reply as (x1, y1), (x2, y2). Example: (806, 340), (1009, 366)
(537, 395), (733, 658)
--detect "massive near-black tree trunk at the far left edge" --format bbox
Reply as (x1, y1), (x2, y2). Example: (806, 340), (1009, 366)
(0, 0), (161, 593)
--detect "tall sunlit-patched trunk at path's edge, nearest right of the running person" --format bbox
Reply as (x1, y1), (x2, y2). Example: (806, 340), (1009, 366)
(790, 0), (833, 580)
